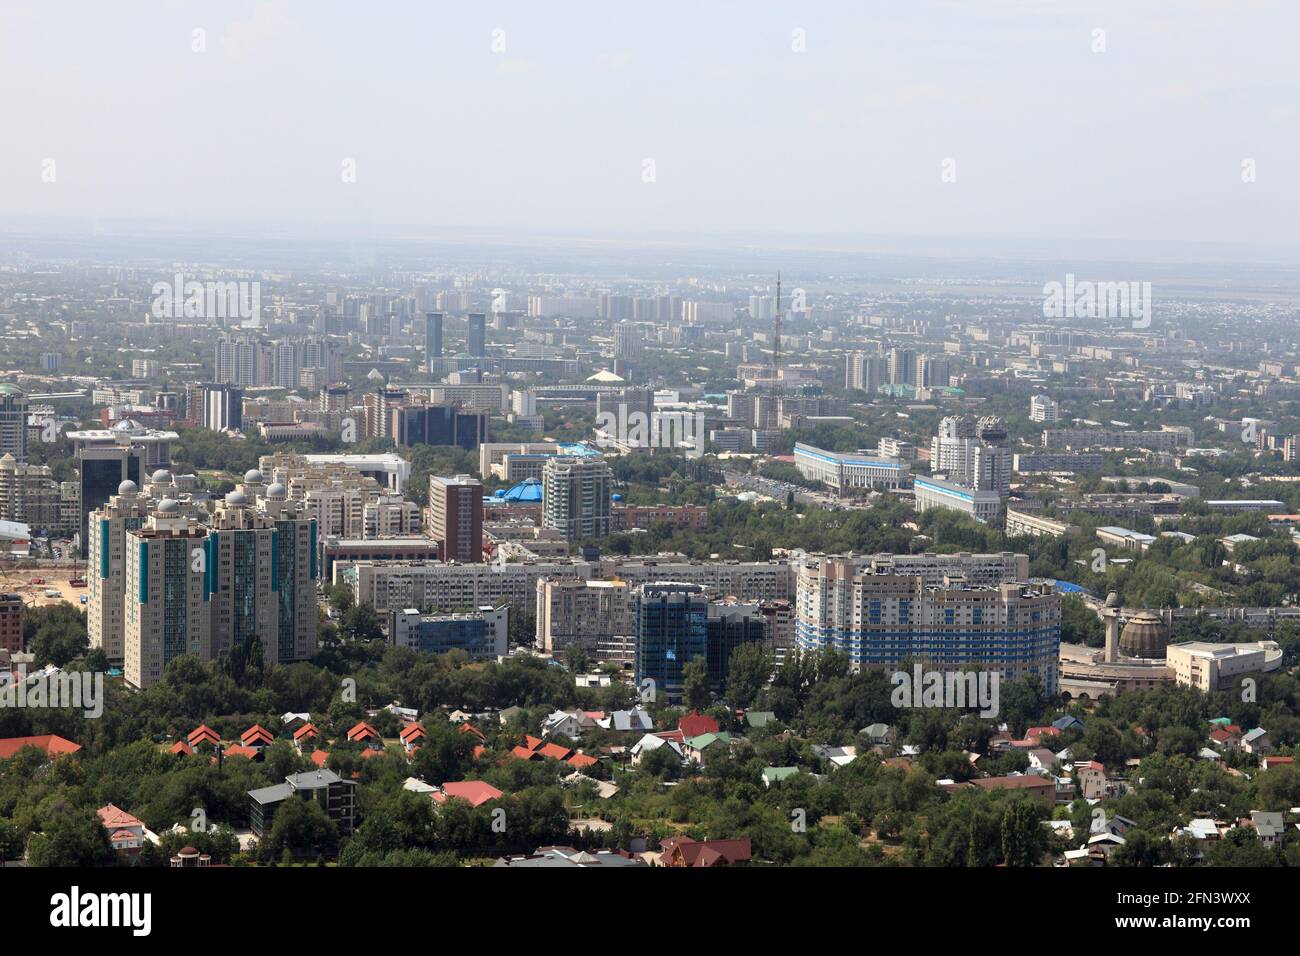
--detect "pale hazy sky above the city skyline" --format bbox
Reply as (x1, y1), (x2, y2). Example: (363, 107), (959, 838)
(0, 0), (1300, 251)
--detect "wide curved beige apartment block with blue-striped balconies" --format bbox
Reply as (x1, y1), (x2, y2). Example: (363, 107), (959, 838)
(796, 558), (1061, 695)
